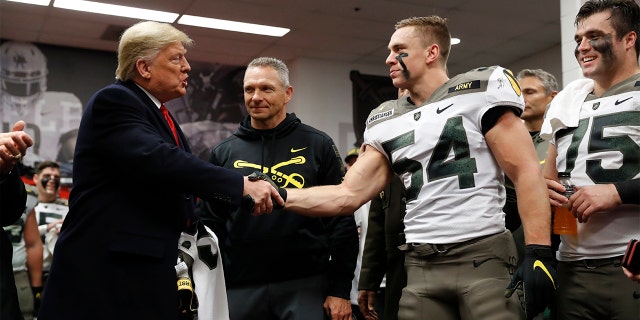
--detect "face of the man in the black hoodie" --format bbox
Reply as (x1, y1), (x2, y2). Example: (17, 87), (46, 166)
(243, 67), (293, 129)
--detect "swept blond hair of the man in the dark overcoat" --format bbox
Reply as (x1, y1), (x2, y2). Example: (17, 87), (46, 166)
(116, 21), (193, 81)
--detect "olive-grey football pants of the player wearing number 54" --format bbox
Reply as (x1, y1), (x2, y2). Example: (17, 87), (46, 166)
(398, 230), (524, 320)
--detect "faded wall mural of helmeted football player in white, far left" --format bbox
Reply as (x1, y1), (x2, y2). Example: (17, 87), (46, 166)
(0, 41), (82, 167)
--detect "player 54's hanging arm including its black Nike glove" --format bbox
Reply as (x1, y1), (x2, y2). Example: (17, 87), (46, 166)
(492, 112), (557, 319)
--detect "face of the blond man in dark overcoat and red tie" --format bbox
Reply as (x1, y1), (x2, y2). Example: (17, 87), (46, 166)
(138, 42), (191, 102)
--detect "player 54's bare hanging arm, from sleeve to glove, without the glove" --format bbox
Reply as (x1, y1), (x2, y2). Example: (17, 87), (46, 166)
(485, 112), (555, 245)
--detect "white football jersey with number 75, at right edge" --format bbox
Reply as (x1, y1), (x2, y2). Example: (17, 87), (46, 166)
(550, 75), (640, 261)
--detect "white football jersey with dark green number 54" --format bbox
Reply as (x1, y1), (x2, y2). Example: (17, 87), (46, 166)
(364, 66), (524, 243)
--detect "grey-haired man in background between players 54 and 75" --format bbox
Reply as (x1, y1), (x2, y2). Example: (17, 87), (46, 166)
(503, 69), (558, 263)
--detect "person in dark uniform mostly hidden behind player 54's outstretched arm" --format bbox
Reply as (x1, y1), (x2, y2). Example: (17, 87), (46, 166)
(358, 89), (408, 320)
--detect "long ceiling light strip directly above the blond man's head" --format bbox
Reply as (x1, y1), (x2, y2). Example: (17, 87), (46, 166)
(53, 0), (178, 23)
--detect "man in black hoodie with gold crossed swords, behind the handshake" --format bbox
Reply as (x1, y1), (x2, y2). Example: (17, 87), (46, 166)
(202, 57), (358, 320)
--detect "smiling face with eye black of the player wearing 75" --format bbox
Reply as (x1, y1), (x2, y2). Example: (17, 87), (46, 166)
(574, 11), (624, 81)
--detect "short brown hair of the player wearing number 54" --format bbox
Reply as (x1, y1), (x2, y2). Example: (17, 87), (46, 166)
(395, 16), (451, 66)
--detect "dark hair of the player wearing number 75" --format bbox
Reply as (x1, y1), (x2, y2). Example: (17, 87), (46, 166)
(575, 0), (640, 59)
